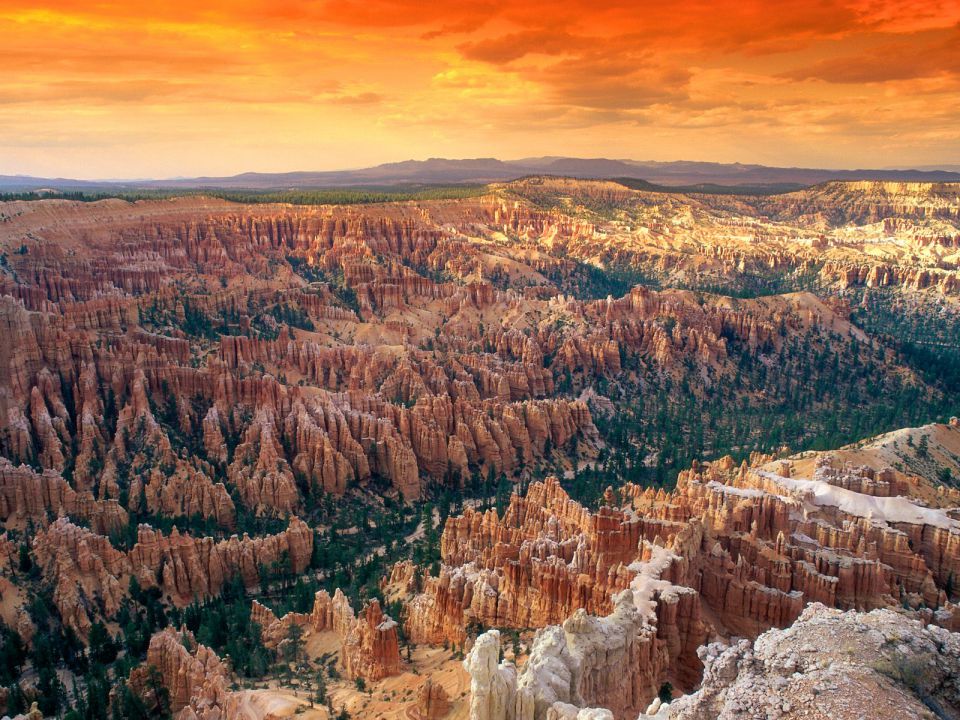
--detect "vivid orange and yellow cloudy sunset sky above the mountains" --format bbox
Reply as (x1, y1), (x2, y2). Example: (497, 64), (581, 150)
(0, 0), (960, 178)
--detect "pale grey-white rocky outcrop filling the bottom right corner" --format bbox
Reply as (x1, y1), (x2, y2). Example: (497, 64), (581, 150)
(672, 603), (960, 720)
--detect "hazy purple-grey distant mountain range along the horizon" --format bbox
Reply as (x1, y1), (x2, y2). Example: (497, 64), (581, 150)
(0, 157), (960, 192)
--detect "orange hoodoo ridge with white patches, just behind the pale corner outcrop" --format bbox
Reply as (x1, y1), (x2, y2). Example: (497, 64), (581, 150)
(424, 442), (960, 720)
